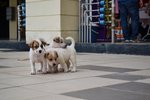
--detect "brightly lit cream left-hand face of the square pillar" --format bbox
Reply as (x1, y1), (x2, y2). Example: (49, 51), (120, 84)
(26, 0), (61, 43)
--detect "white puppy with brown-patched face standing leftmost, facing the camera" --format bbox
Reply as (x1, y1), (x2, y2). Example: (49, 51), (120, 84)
(29, 39), (48, 75)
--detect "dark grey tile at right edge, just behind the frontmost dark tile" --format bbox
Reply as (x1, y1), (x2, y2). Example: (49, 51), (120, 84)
(107, 82), (150, 95)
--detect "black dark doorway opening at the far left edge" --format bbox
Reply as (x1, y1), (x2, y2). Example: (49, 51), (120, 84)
(0, 0), (9, 40)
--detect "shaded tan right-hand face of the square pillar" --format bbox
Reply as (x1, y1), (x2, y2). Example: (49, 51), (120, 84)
(61, 0), (79, 41)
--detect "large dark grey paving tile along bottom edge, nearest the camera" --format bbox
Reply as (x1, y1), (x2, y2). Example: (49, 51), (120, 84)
(62, 87), (150, 100)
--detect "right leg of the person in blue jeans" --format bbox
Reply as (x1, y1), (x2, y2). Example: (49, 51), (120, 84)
(128, 2), (139, 40)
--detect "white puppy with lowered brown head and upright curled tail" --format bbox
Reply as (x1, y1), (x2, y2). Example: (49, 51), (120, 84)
(45, 37), (76, 72)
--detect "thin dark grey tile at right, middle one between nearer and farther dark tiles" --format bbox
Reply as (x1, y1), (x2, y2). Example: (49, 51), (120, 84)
(98, 73), (150, 81)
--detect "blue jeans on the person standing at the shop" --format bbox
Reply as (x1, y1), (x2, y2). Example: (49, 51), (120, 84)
(118, 0), (139, 40)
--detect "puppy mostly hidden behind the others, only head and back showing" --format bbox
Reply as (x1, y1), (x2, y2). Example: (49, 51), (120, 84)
(50, 36), (67, 48)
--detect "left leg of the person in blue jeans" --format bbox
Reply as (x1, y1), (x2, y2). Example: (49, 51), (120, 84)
(119, 2), (129, 40)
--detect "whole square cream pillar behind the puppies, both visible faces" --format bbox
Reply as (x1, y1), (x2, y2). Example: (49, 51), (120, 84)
(26, 0), (78, 43)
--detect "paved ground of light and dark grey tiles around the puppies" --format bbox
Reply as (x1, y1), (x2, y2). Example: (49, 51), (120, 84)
(0, 49), (150, 100)
